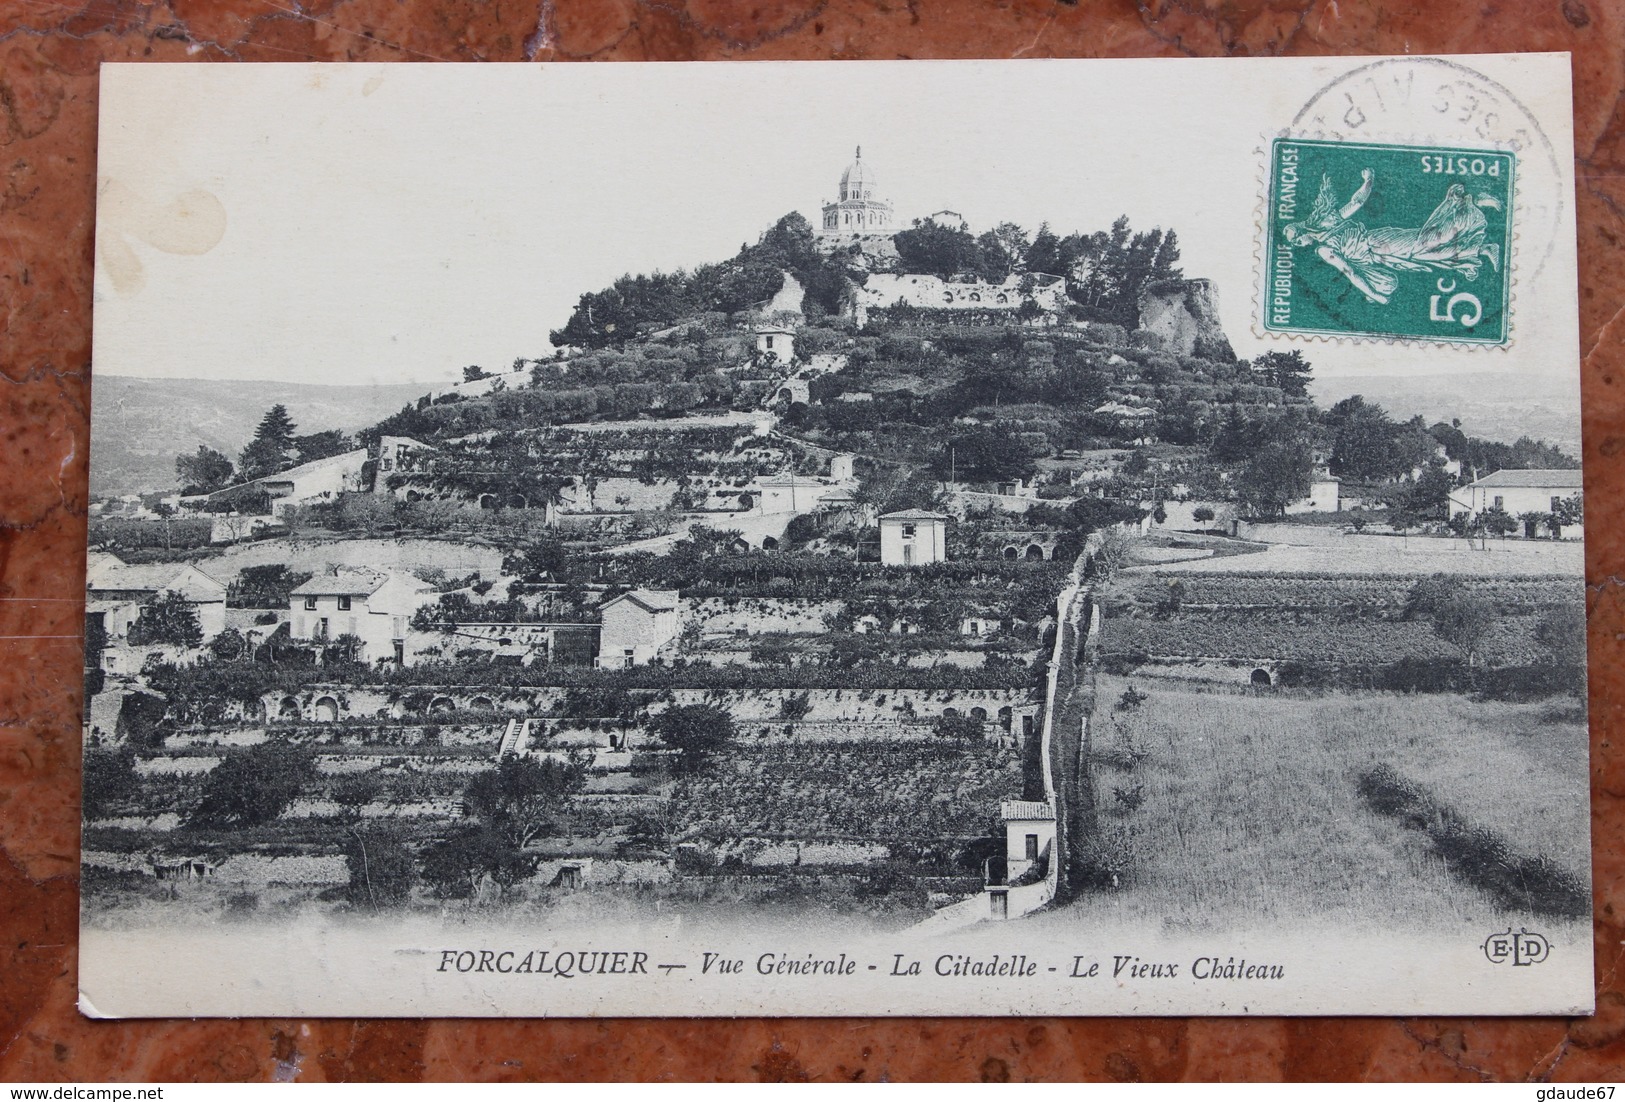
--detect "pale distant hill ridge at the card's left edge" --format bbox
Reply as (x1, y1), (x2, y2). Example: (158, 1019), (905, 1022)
(91, 375), (429, 496)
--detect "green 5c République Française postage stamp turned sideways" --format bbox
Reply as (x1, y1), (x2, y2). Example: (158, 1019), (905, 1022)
(1259, 138), (1516, 345)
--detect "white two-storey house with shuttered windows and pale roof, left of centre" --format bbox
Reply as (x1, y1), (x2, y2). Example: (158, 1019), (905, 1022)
(288, 567), (436, 663)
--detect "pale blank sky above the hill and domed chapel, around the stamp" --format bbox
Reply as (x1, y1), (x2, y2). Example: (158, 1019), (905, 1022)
(94, 55), (1578, 393)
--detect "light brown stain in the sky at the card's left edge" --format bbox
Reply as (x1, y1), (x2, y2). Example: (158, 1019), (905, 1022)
(96, 180), (226, 294)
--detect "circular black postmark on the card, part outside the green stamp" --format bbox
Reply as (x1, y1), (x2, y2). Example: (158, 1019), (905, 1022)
(1289, 57), (1565, 278)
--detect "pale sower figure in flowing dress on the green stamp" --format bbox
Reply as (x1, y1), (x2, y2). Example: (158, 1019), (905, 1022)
(1284, 169), (1502, 306)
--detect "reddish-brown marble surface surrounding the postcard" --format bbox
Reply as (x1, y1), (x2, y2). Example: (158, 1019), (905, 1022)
(0, 0), (1625, 1082)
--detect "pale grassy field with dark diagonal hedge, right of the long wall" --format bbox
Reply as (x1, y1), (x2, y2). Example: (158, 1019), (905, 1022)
(1050, 678), (1589, 931)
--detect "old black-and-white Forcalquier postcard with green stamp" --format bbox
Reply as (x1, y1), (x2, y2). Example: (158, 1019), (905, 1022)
(80, 54), (1593, 1017)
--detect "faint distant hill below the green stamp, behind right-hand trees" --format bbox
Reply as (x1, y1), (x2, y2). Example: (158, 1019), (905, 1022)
(1310, 372), (1580, 457)
